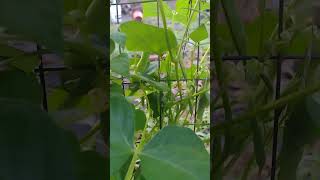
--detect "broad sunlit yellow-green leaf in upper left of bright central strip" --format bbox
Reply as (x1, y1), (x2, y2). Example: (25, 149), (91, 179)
(120, 21), (177, 54)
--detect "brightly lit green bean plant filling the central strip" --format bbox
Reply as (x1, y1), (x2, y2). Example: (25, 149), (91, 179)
(110, 0), (210, 180)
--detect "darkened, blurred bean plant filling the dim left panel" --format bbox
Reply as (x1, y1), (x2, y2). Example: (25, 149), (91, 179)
(0, 0), (109, 180)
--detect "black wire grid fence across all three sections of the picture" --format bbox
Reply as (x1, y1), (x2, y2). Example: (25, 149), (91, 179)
(20, 0), (320, 180)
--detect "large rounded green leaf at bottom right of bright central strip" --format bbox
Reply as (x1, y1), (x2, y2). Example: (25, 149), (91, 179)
(140, 126), (210, 180)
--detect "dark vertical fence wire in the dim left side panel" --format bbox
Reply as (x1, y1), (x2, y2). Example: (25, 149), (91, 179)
(37, 44), (48, 111)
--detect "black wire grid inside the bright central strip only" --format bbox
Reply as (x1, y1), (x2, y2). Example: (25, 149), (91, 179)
(110, 0), (208, 131)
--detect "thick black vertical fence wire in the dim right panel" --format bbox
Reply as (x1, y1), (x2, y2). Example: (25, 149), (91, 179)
(271, 0), (284, 180)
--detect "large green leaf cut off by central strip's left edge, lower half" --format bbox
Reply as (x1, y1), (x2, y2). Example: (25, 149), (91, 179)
(110, 95), (135, 175)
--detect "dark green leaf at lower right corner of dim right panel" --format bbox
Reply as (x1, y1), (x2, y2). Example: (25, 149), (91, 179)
(279, 95), (320, 180)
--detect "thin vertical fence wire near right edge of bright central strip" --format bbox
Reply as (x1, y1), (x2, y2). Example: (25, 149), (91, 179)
(193, 2), (201, 132)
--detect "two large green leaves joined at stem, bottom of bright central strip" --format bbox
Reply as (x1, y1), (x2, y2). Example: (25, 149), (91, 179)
(110, 95), (209, 180)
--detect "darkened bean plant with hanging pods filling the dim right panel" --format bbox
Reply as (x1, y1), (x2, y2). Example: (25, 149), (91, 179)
(211, 0), (320, 180)
